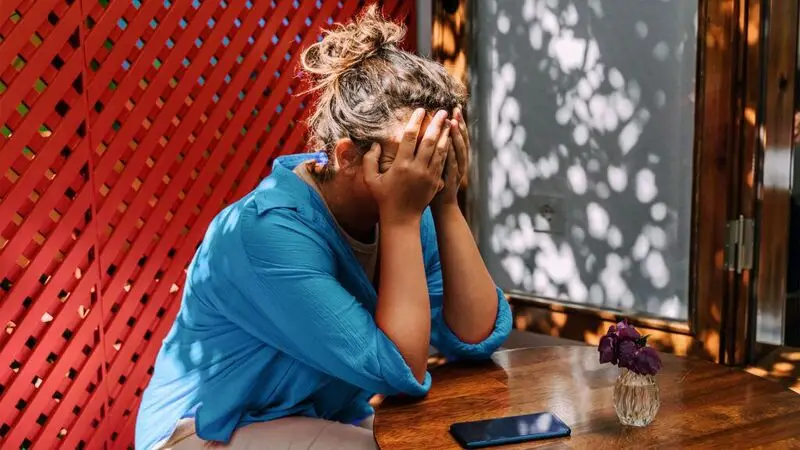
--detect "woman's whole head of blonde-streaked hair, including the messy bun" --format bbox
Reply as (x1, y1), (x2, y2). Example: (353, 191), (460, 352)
(301, 4), (467, 177)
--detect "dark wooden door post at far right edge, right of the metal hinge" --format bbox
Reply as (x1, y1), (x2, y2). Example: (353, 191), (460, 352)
(746, 0), (800, 362)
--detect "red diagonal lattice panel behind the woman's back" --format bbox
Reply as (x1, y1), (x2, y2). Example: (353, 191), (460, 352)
(0, 0), (414, 449)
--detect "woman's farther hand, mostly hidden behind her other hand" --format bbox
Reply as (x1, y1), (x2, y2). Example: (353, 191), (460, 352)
(431, 108), (470, 212)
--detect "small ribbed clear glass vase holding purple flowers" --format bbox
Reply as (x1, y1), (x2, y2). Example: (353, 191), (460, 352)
(614, 369), (661, 427)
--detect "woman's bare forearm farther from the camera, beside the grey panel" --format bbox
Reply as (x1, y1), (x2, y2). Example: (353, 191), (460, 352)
(434, 204), (497, 344)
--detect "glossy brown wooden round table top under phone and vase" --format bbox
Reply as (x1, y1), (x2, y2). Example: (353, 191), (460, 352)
(374, 346), (800, 450)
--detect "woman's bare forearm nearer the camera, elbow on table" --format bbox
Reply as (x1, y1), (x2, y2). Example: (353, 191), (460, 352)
(375, 221), (431, 382)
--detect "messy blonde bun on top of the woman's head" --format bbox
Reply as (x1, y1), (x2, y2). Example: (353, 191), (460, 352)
(302, 4), (406, 82)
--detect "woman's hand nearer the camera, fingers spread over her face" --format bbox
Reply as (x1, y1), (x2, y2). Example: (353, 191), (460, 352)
(364, 108), (450, 224)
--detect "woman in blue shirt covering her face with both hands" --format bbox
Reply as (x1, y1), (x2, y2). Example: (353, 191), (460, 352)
(136, 7), (511, 449)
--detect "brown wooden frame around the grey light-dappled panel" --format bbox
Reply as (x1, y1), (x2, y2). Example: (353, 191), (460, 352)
(432, 0), (764, 364)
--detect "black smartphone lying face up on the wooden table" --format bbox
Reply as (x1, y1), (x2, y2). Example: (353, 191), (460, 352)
(450, 413), (572, 449)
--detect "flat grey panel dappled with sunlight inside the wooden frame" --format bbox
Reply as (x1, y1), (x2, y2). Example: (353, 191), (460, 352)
(472, 0), (697, 320)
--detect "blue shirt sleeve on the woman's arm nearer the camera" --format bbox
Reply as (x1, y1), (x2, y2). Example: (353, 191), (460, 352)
(225, 209), (431, 396)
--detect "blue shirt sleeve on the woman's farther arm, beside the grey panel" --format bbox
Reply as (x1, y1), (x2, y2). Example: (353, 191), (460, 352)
(422, 211), (511, 359)
